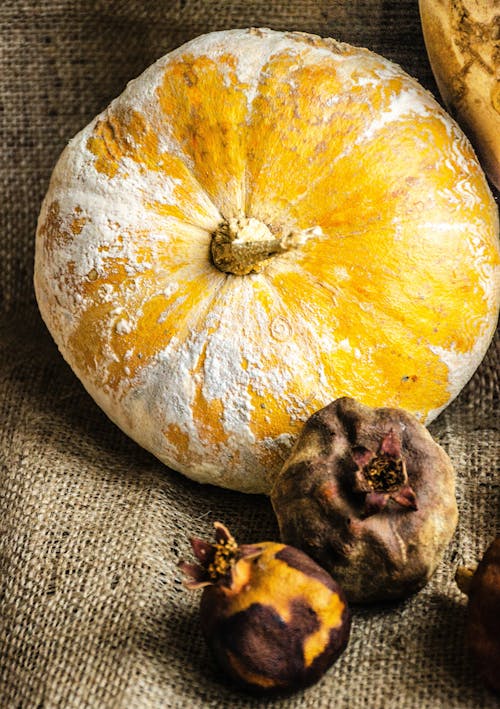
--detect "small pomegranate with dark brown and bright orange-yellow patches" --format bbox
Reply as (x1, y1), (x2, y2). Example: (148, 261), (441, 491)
(180, 522), (350, 693)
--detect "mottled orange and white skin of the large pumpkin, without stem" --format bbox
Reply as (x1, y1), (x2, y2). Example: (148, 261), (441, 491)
(35, 30), (499, 492)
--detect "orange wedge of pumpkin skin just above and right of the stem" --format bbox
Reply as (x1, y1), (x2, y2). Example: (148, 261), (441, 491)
(246, 55), (401, 228)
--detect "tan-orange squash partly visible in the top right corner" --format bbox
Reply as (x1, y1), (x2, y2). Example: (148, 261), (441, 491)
(419, 0), (500, 190)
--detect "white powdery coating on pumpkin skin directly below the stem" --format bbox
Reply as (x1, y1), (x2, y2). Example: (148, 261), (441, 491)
(116, 276), (338, 492)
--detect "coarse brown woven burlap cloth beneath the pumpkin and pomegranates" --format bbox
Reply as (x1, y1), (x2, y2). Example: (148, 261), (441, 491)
(0, 0), (500, 709)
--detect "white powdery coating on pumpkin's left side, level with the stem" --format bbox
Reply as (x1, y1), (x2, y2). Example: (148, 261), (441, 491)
(35, 129), (215, 360)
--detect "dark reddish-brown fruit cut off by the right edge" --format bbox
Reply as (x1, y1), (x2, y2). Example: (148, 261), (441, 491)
(456, 537), (500, 692)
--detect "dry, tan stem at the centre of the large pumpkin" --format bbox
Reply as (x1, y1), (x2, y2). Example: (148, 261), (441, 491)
(210, 217), (321, 276)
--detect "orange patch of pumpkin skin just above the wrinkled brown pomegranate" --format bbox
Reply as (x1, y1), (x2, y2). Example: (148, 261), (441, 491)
(266, 262), (449, 416)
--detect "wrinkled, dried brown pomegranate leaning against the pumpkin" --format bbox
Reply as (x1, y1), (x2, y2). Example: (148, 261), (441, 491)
(271, 397), (458, 603)
